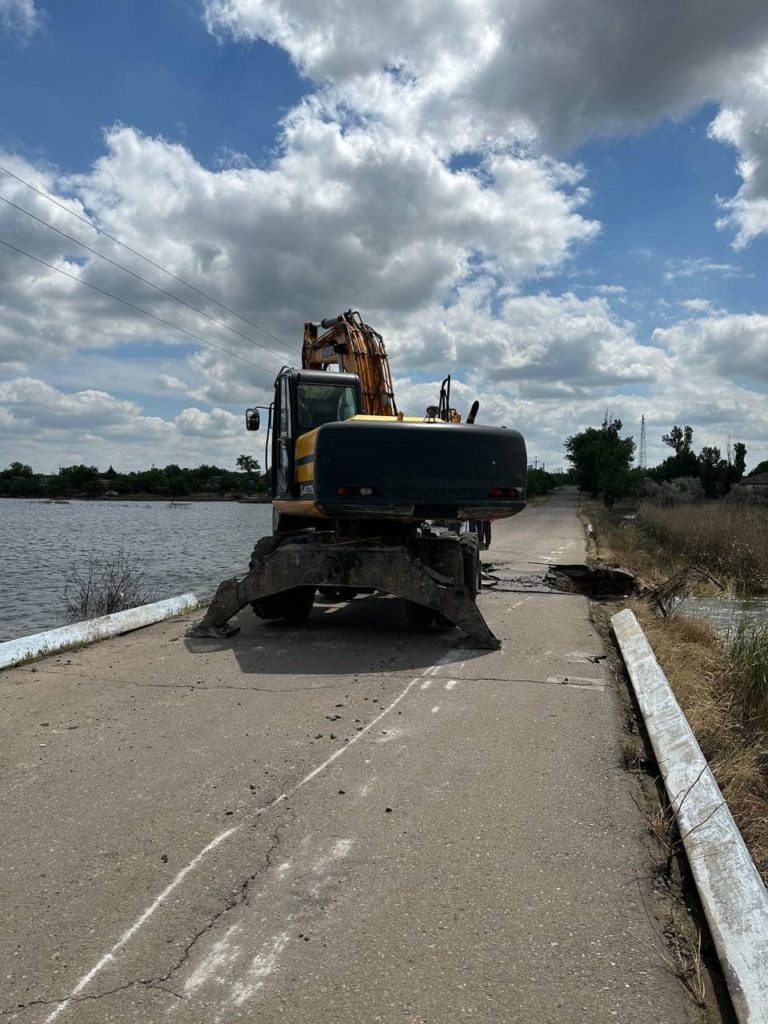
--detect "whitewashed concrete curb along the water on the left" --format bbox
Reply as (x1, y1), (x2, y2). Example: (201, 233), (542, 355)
(0, 593), (201, 669)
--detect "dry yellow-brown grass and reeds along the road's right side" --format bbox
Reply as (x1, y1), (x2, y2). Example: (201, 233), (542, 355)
(582, 495), (768, 884)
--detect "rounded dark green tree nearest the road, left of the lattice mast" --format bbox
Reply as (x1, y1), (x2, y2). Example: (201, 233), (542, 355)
(565, 417), (635, 508)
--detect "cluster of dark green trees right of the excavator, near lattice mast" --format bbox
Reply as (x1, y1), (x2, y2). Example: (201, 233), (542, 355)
(565, 415), (757, 508)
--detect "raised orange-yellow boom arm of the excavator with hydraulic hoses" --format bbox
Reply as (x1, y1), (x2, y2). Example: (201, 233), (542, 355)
(301, 309), (397, 416)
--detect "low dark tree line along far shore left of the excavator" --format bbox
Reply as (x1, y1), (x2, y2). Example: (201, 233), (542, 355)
(0, 455), (267, 499)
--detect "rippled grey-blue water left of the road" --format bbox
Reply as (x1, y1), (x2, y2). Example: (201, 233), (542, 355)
(0, 499), (271, 641)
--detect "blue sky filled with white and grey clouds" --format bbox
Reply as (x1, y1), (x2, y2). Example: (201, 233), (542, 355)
(0, 0), (768, 472)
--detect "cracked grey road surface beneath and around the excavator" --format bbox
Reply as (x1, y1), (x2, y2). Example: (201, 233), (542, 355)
(0, 493), (696, 1024)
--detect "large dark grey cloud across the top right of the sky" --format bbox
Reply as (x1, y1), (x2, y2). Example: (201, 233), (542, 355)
(205, 0), (768, 144)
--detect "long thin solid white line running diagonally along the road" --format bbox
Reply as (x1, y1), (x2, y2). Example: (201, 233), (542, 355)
(45, 650), (464, 1024)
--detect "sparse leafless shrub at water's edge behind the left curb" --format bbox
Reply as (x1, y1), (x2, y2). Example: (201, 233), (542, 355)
(63, 549), (155, 622)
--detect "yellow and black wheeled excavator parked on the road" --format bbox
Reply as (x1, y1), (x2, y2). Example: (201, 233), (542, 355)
(189, 309), (527, 649)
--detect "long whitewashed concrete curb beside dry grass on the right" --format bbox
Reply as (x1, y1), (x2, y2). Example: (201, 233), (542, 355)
(611, 609), (768, 1024)
